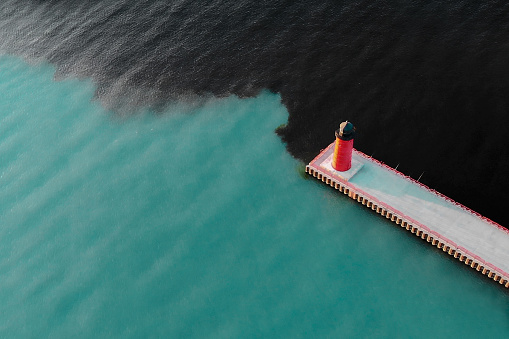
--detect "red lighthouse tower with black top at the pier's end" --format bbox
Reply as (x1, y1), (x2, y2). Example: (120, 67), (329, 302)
(332, 120), (355, 172)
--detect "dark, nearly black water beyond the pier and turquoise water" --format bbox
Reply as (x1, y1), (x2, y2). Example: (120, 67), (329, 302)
(0, 0), (509, 225)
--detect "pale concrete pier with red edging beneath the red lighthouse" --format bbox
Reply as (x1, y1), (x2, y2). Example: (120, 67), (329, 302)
(306, 143), (509, 288)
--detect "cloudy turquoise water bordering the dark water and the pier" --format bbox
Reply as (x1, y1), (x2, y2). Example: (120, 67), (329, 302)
(0, 56), (509, 338)
